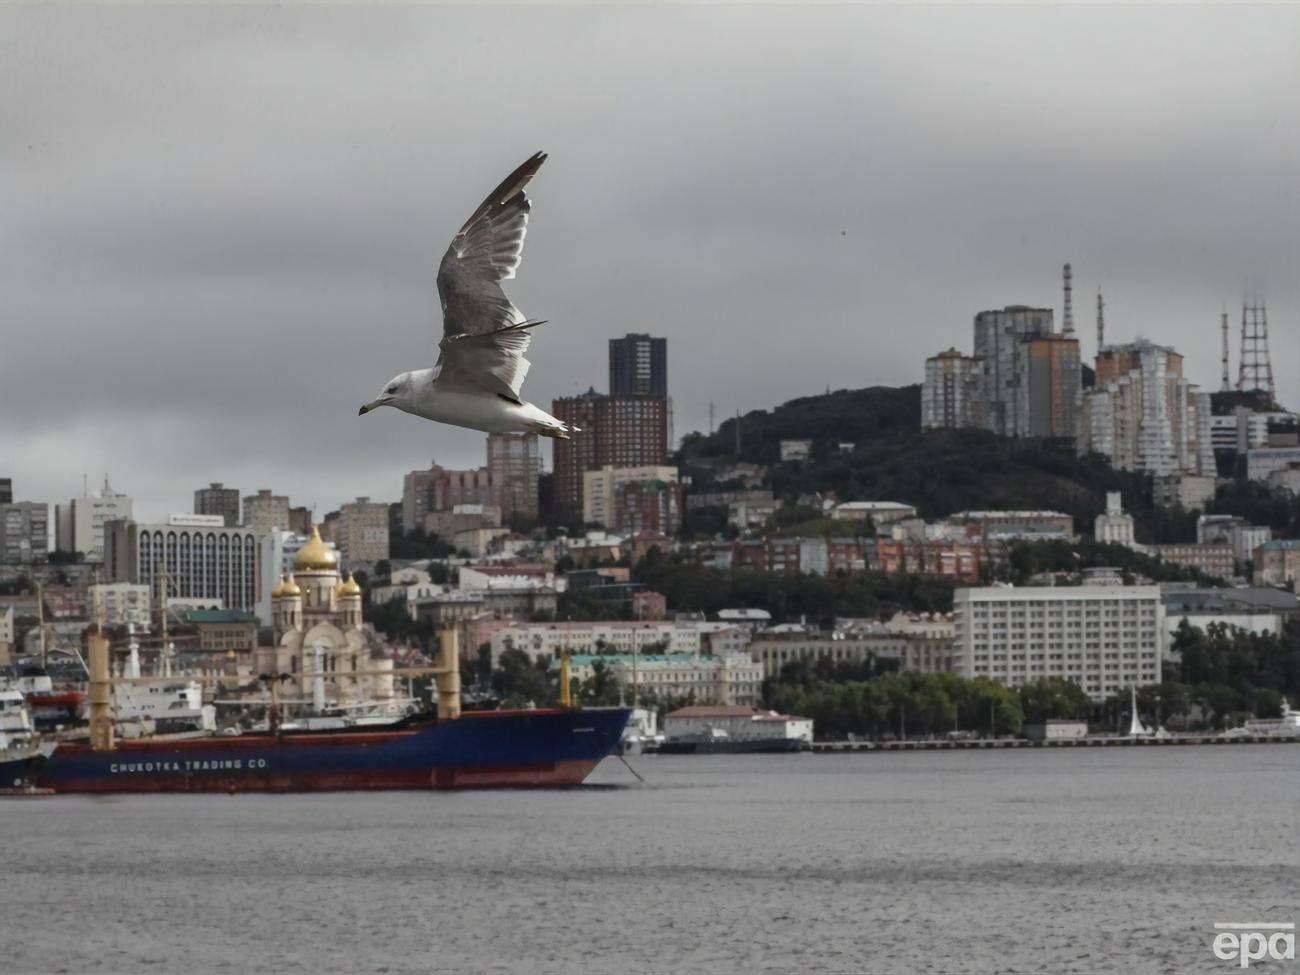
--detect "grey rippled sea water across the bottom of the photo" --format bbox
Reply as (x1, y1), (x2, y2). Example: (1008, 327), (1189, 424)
(0, 745), (1300, 974)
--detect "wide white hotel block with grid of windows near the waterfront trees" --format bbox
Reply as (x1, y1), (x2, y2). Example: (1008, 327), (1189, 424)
(953, 586), (1166, 701)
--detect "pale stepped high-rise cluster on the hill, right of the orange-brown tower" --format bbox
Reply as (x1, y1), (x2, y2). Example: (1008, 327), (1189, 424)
(1076, 339), (1216, 477)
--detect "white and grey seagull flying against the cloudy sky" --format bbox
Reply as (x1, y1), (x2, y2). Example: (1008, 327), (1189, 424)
(359, 152), (577, 439)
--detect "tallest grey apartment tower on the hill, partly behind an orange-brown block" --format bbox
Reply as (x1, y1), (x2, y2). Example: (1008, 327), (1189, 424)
(975, 304), (1052, 437)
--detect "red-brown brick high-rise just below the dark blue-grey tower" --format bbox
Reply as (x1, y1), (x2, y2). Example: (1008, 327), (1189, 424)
(551, 390), (668, 523)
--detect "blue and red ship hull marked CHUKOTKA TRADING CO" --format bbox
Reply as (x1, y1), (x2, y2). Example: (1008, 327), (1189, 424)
(19, 707), (631, 793)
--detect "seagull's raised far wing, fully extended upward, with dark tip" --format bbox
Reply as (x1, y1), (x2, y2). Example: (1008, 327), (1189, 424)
(438, 152), (546, 338)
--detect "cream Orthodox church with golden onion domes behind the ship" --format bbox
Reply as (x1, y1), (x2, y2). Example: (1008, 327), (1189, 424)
(256, 525), (393, 707)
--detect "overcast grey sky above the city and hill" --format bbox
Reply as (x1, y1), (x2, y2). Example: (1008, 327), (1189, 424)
(0, 5), (1300, 517)
